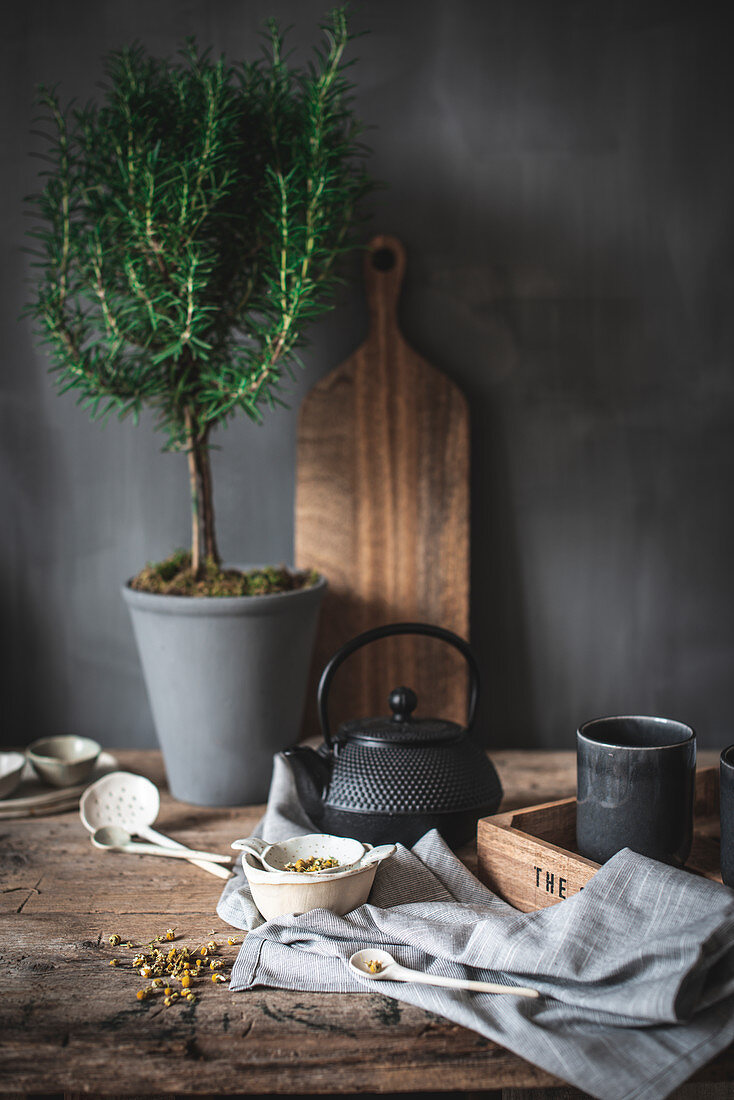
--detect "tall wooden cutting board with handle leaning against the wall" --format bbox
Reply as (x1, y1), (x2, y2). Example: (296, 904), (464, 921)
(295, 235), (469, 734)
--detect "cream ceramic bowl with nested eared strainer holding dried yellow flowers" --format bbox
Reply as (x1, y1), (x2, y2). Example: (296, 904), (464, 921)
(242, 833), (387, 921)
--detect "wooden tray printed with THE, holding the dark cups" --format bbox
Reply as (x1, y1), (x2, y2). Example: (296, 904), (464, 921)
(476, 768), (721, 913)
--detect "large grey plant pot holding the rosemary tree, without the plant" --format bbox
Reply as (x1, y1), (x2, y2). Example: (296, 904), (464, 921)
(122, 579), (326, 806)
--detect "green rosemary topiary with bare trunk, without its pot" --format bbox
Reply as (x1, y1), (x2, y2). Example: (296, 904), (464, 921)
(28, 9), (372, 594)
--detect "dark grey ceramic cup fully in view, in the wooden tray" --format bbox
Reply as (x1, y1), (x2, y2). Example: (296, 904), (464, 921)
(576, 716), (695, 867)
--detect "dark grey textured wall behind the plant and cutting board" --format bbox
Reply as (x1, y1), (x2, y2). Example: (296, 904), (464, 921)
(0, 0), (734, 747)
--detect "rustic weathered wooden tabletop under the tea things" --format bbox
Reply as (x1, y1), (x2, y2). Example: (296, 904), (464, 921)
(0, 751), (734, 1100)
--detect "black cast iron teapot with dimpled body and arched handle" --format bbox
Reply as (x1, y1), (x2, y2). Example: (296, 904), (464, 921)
(285, 623), (502, 847)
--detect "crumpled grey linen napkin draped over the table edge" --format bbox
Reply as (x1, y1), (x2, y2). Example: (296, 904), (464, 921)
(217, 757), (734, 1100)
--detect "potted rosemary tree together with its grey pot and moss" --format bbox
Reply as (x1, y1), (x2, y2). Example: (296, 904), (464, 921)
(28, 9), (372, 805)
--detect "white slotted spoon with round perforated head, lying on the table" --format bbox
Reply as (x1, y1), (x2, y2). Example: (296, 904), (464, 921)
(79, 771), (231, 879)
